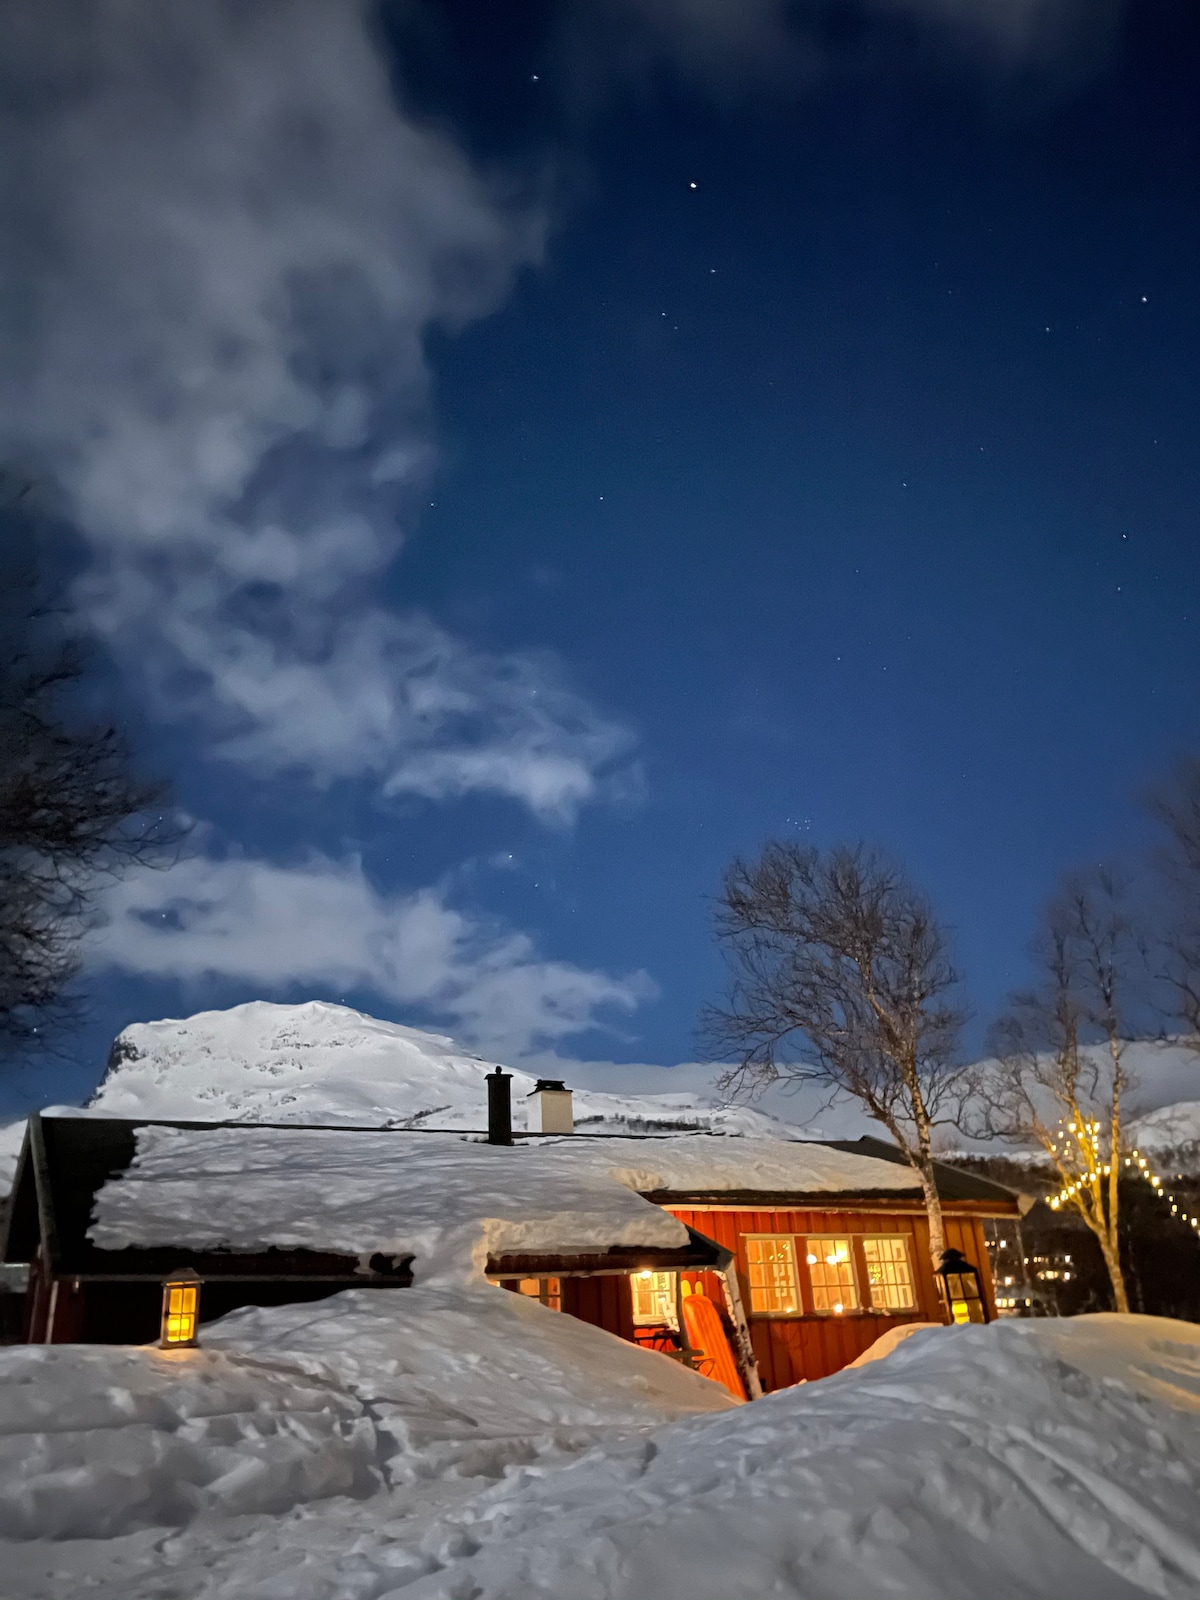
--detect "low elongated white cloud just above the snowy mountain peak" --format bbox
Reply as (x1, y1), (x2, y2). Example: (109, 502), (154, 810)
(88, 856), (654, 1059)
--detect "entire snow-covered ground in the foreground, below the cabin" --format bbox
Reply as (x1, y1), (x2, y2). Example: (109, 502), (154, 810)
(0, 1286), (1200, 1600)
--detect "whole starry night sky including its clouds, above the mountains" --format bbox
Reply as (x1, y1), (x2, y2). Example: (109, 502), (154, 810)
(2, 0), (1200, 1120)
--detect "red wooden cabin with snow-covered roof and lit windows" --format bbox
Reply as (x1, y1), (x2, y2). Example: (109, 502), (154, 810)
(0, 1117), (1018, 1397)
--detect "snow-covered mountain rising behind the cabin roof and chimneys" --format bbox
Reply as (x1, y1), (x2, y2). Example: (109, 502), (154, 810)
(88, 1000), (795, 1136)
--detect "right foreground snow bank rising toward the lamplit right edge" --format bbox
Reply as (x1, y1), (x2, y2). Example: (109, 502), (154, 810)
(390, 1317), (1200, 1600)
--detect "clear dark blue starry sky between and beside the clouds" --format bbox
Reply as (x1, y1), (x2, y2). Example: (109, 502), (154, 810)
(2, 3), (1200, 1113)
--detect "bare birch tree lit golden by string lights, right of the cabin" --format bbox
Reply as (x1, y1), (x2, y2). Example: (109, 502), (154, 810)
(973, 872), (1144, 1310)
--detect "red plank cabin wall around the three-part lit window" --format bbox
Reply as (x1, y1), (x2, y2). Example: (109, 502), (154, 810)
(670, 1206), (995, 1390)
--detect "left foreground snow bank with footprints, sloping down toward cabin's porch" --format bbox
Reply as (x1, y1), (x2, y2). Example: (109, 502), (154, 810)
(0, 1285), (733, 1600)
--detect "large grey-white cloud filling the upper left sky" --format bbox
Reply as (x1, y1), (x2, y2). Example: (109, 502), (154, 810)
(0, 0), (640, 818)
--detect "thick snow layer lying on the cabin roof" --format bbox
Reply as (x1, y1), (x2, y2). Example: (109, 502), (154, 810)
(88, 1125), (912, 1280)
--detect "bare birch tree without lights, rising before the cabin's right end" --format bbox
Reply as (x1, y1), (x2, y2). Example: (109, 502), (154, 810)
(704, 843), (970, 1264)
